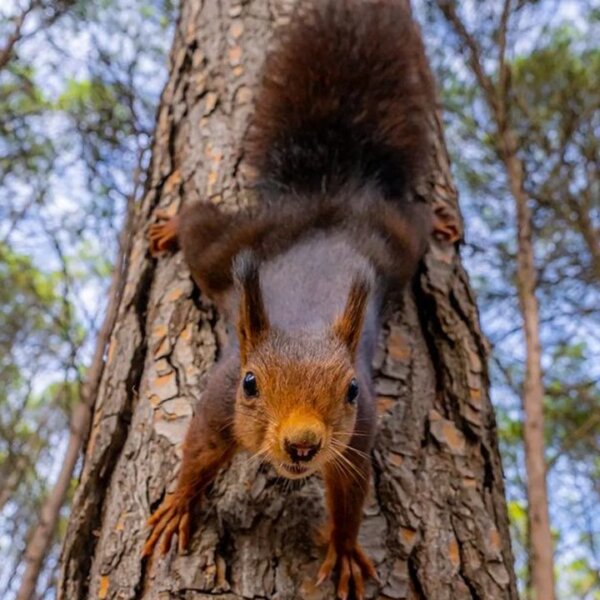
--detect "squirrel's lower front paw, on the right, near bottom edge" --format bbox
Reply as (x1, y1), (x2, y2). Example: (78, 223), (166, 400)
(317, 542), (377, 600)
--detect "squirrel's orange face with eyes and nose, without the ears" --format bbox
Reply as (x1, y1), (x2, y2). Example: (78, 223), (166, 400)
(234, 331), (360, 479)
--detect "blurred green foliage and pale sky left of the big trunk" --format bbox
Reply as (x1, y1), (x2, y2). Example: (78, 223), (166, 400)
(0, 0), (175, 598)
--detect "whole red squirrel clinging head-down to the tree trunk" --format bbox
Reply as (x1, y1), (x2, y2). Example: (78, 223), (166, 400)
(144, 0), (434, 599)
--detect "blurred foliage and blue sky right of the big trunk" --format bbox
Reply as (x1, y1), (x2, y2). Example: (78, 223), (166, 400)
(418, 0), (600, 600)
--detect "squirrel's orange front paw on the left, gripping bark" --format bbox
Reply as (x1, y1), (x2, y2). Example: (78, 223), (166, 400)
(142, 493), (190, 557)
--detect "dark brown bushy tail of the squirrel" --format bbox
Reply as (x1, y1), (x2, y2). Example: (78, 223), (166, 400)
(246, 0), (434, 197)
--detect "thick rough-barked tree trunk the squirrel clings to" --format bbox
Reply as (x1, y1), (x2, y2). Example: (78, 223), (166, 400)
(59, 0), (517, 600)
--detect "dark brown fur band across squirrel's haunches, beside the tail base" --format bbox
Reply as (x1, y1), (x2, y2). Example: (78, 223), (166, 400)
(180, 186), (431, 298)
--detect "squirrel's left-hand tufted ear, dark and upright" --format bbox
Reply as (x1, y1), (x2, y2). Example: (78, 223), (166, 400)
(233, 250), (269, 364)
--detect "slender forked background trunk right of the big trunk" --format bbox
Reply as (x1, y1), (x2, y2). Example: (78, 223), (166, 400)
(437, 0), (555, 600)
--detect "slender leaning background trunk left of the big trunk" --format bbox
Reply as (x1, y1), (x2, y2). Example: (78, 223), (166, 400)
(16, 202), (133, 600)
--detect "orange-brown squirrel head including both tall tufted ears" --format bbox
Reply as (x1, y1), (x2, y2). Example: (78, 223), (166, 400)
(234, 254), (371, 479)
